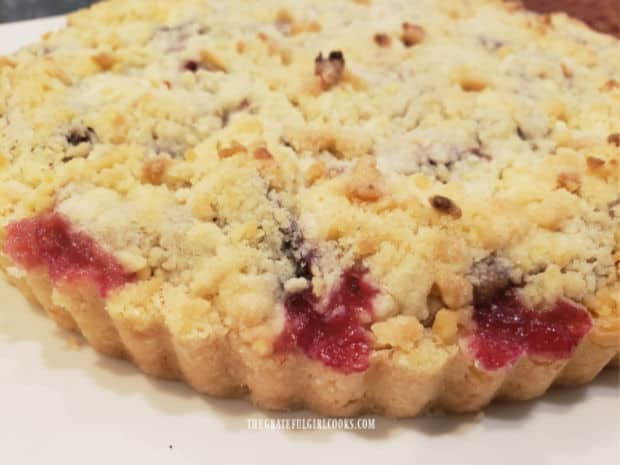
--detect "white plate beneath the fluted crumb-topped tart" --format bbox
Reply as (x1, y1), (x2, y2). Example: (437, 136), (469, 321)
(0, 14), (620, 465)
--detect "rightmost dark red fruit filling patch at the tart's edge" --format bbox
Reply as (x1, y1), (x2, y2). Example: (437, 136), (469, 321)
(469, 290), (592, 370)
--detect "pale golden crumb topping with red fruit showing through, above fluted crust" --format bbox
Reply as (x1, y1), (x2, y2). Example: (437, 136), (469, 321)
(0, 0), (620, 373)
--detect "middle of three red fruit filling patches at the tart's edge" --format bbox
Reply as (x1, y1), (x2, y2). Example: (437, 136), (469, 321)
(275, 267), (378, 374)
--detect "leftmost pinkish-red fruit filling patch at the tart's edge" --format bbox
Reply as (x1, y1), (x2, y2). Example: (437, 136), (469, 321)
(3, 212), (134, 297)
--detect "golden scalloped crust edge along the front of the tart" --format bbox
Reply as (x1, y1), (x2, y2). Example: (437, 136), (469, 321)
(0, 257), (620, 417)
